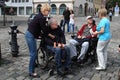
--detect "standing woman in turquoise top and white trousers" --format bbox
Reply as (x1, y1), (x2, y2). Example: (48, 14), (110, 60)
(93, 8), (111, 70)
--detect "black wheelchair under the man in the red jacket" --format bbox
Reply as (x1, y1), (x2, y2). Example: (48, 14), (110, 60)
(71, 35), (98, 64)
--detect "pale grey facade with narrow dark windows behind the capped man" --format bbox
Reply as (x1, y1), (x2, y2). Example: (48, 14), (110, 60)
(73, 0), (94, 16)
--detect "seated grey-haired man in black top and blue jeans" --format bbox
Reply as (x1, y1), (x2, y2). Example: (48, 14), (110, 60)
(45, 18), (71, 75)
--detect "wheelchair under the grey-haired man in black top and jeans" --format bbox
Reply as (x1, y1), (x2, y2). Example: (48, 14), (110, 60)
(36, 37), (66, 76)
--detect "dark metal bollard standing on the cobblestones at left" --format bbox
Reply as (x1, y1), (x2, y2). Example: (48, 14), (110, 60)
(9, 24), (19, 57)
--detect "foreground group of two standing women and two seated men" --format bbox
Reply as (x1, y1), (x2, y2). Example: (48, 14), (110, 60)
(25, 4), (111, 77)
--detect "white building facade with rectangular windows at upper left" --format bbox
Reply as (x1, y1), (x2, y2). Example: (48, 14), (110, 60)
(0, 0), (33, 16)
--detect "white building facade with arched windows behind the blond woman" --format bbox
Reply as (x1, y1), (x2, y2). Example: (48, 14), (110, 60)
(33, 0), (74, 15)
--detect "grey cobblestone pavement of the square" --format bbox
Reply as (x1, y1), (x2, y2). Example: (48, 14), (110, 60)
(0, 17), (120, 80)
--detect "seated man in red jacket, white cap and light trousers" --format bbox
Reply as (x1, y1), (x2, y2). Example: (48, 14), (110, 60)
(69, 16), (96, 63)
